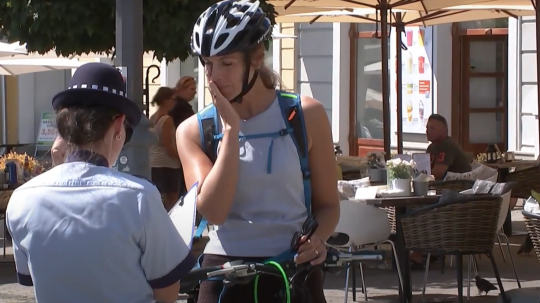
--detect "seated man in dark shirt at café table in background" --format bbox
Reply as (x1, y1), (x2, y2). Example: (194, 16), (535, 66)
(426, 114), (472, 180)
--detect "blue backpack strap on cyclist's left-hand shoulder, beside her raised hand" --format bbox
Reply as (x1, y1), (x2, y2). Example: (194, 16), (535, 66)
(197, 104), (220, 162)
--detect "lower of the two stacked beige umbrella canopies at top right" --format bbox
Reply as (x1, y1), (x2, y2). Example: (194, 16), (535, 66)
(276, 4), (535, 26)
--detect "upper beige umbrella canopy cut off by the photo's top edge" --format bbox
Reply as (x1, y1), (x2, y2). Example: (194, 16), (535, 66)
(269, 0), (498, 14)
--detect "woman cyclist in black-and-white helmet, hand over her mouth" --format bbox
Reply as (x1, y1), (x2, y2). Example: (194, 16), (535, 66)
(176, 0), (339, 303)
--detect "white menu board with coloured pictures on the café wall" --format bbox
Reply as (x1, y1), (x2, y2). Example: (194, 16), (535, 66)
(395, 26), (433, 134)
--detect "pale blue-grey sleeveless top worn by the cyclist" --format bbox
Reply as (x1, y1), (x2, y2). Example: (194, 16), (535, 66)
(204, 98), (307, 257)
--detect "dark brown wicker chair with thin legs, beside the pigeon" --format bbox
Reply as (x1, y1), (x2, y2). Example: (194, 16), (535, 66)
(400, 195), (506, 303)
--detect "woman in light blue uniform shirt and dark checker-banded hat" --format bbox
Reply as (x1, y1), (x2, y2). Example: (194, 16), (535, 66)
(7, 63), (195, 303)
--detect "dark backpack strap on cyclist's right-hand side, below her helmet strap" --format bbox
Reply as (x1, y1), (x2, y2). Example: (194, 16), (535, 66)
(277, 91), (311, 214)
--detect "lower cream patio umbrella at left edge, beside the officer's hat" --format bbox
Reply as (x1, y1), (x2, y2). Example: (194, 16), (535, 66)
(0, 58), (84, 76)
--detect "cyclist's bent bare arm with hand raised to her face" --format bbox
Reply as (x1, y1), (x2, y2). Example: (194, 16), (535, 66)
(176, 115), (240, 224)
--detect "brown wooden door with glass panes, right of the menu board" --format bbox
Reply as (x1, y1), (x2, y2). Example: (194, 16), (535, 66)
(460, 35), (508, 153)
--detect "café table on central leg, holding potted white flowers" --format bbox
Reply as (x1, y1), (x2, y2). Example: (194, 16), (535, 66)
(355, 195), (440, 303)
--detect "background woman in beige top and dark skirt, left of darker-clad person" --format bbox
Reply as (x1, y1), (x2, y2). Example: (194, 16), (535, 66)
(150, 87), (184, 210)
